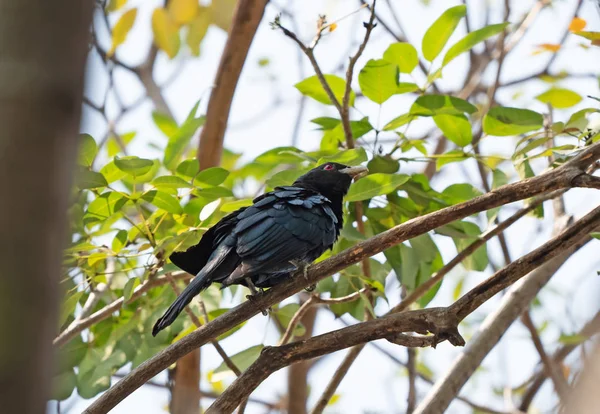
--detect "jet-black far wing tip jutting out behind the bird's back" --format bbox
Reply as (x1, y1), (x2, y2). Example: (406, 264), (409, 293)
(169, 207), (247, 275)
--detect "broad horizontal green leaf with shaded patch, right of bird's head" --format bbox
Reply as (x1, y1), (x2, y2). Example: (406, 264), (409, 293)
(483, 106), (544, 137)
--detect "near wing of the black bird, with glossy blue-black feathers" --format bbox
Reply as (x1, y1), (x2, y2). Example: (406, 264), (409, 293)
(226, 187), (341, 284)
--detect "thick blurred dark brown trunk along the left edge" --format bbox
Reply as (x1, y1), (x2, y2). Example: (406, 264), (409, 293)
(0, 0), (92, 414)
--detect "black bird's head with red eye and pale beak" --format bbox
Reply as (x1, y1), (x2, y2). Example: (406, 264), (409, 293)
(294, 162), (369, 201)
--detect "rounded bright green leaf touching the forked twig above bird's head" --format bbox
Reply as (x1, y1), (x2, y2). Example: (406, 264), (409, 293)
(358, 59), (398, 104)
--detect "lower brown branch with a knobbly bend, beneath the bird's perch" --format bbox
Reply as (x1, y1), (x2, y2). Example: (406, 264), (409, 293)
(207, 207), (600, 414)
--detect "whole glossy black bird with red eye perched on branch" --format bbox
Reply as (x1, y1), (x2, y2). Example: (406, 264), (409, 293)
(152, 162), (367, 336)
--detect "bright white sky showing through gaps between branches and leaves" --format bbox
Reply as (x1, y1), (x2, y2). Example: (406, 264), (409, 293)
(49, 0), (600, 414)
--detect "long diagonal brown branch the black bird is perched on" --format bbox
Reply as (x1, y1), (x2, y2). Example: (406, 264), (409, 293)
(86, 143), (600, 413)
